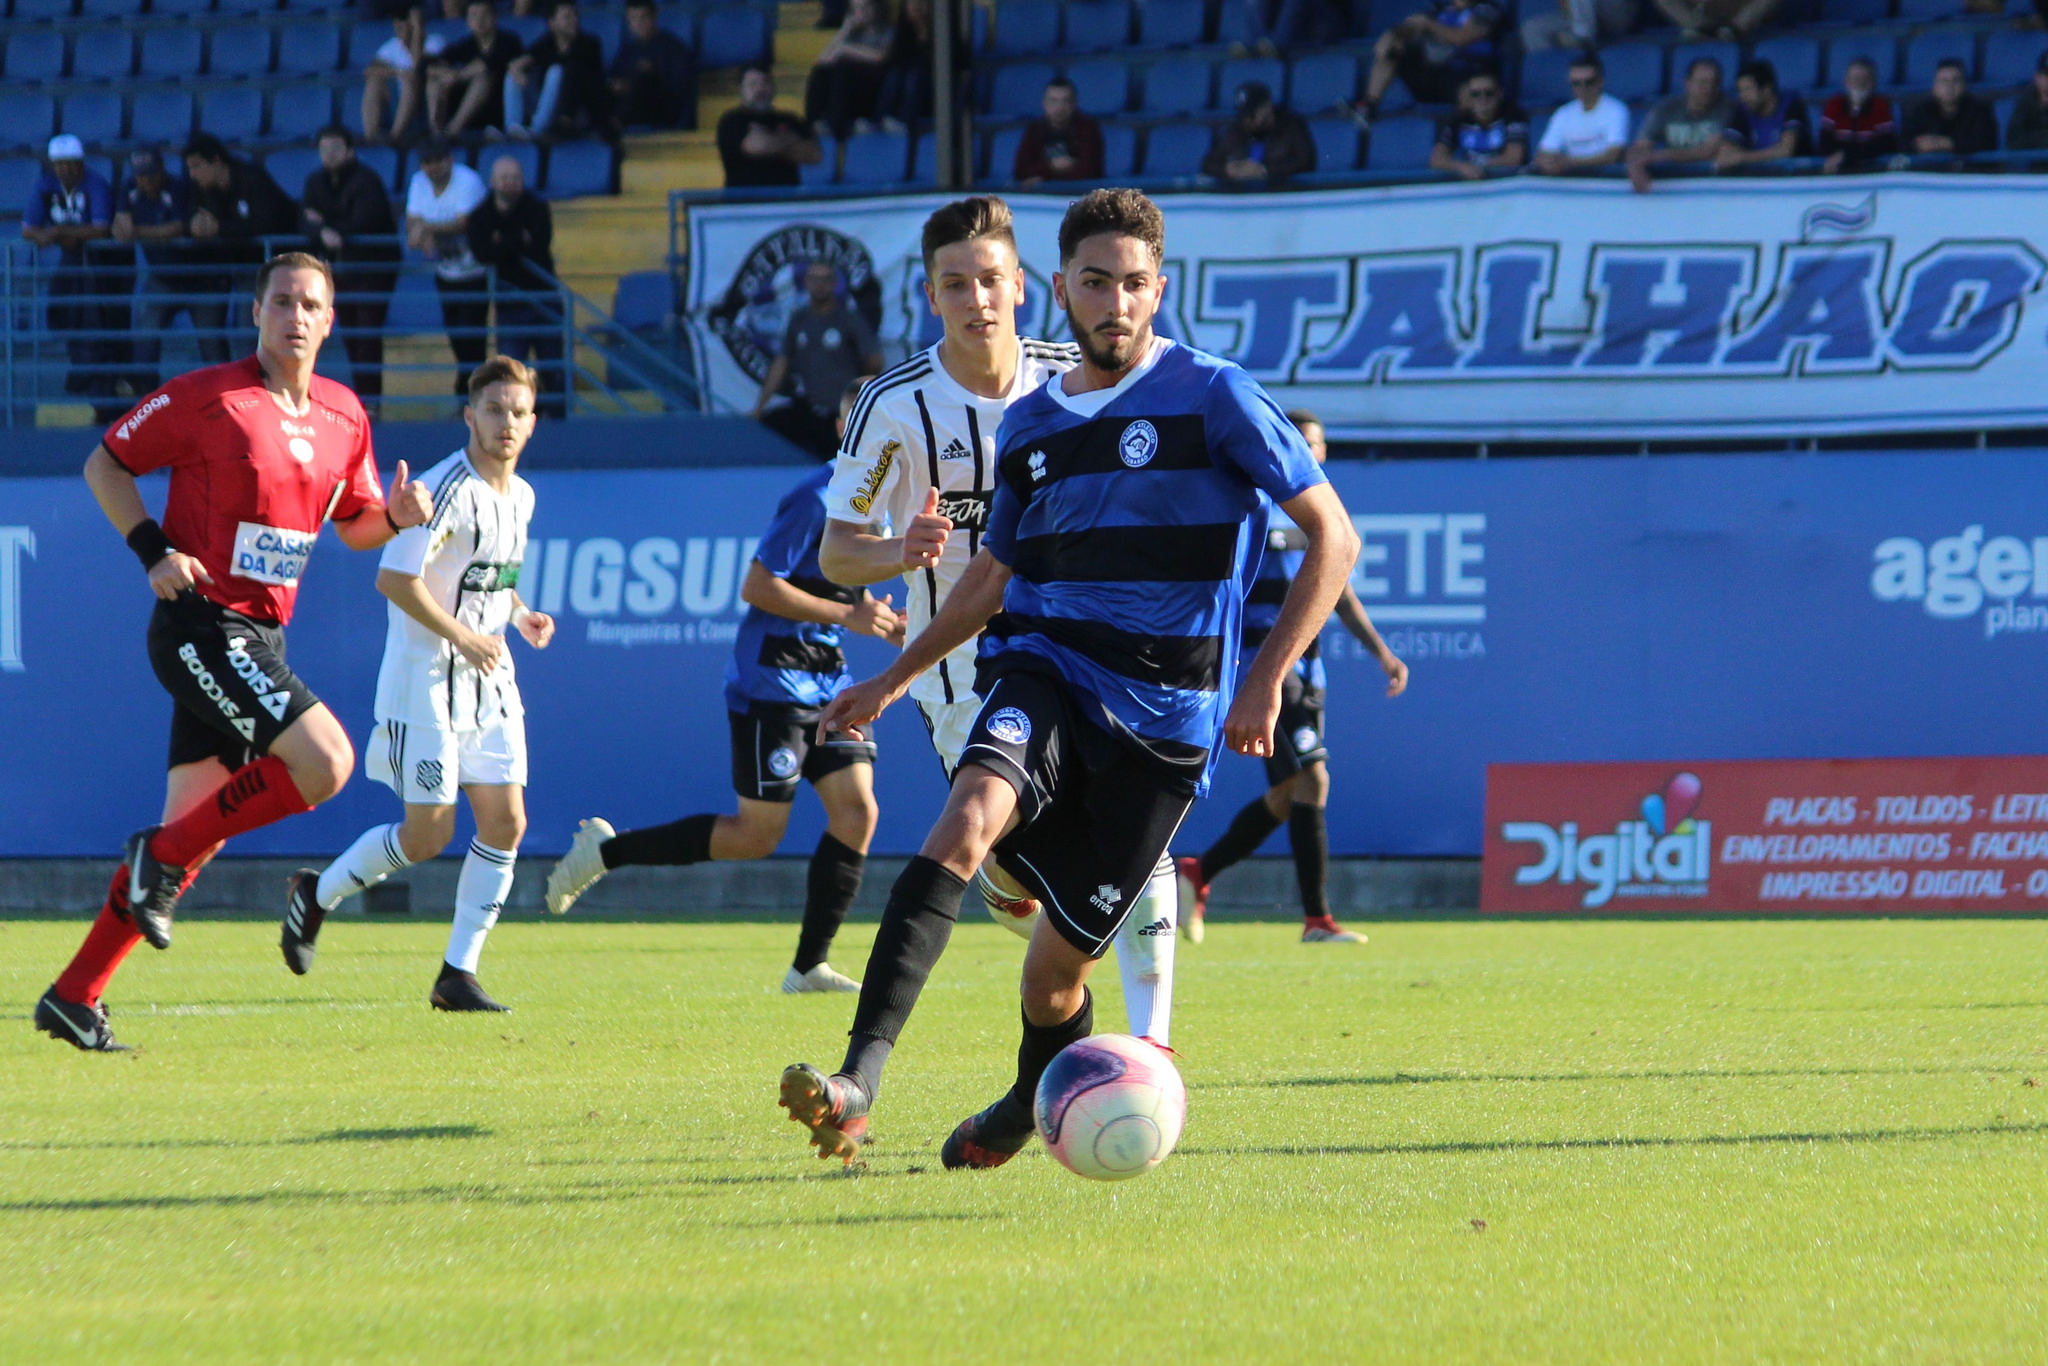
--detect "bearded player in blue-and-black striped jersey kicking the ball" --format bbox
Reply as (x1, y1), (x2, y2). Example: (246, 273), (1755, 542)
(780, 190), (1358, 1167)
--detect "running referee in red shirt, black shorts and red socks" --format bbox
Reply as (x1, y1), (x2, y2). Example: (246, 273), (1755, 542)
(35, 252), (434, 1051)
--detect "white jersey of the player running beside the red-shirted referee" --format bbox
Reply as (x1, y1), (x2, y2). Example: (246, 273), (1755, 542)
(377, 451), (532, 731)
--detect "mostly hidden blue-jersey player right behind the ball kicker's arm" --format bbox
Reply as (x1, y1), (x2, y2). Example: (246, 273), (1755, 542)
(1174, 408), (1407, 944)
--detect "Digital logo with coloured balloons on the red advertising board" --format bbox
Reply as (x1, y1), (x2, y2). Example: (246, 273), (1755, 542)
(1501, 772), (1714, 911)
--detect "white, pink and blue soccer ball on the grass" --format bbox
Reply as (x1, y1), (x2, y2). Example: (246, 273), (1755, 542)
(1034, 1034), (1188, 1182)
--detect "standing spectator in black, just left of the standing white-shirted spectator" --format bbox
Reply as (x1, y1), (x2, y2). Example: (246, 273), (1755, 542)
(299, 127), (401, 418)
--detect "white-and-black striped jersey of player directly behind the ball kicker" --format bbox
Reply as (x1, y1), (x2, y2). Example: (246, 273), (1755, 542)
(825, 338), (1081, 702)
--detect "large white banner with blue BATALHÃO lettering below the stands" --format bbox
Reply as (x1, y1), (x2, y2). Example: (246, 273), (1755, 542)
(688, 174), (2048, 442)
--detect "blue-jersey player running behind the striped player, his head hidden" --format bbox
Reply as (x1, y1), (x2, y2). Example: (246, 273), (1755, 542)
(547, 381), (903, 991)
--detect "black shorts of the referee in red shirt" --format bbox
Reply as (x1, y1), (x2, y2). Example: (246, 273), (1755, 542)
(150, 590), (319, 770)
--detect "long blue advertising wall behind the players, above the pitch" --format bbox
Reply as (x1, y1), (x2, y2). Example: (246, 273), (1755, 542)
(0, 451), (2048, 856)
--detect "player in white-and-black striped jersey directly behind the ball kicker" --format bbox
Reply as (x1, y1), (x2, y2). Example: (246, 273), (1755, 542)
(819, 195), (1176, 1044)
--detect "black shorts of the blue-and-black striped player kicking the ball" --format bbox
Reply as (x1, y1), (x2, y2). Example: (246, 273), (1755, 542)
(961, 674), (1194, 958)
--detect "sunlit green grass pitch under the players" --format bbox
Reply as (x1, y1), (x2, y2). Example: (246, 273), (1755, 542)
(0, 915), (2048, 1366)
